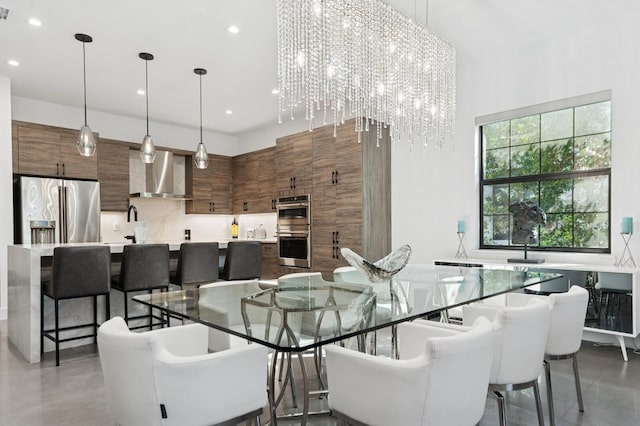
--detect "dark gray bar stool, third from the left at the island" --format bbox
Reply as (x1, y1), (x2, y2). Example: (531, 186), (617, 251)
(171, 243), (219, 289)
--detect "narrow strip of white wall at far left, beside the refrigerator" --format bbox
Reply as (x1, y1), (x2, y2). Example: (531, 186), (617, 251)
(0, 76), (13, 320)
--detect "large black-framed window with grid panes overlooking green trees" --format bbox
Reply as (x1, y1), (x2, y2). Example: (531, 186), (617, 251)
(476, 91), (611, 253)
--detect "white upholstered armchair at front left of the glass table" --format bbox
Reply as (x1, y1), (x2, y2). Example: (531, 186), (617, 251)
(98, 317), (267, 426)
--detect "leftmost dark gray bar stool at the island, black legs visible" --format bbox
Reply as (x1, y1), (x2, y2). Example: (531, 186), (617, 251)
(40, 245), (111, 366)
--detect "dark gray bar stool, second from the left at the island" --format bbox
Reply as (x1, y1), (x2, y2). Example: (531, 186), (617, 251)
(111, 244), (169, 330)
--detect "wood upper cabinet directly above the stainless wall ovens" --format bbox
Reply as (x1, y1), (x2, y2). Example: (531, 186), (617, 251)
(275, 130), (315, 194)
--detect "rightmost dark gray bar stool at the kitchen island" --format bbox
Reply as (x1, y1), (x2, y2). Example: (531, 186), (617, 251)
(220, 241), (262, 281)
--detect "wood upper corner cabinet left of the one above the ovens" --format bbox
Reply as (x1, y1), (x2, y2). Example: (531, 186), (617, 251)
(231, 147), (276, 214)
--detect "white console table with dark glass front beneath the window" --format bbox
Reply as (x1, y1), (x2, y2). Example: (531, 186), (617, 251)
(434, 259), (640, 361)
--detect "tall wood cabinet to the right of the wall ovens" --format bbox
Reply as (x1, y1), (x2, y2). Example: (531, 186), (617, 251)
(311, 120), (391, 279)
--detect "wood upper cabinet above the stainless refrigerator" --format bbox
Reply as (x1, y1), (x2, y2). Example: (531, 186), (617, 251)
(12, 121), (99, 179)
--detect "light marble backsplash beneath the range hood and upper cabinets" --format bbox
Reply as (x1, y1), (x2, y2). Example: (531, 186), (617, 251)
(100, 198), (276, 242)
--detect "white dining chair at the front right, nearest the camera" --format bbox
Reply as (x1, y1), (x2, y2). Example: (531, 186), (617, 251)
(325, 318), (494, 426)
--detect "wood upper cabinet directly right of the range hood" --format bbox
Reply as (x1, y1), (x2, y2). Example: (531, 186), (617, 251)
(185, 154), (231, 214)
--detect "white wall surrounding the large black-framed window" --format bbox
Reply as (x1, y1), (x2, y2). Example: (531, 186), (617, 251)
(392, 11), (640, 264)
